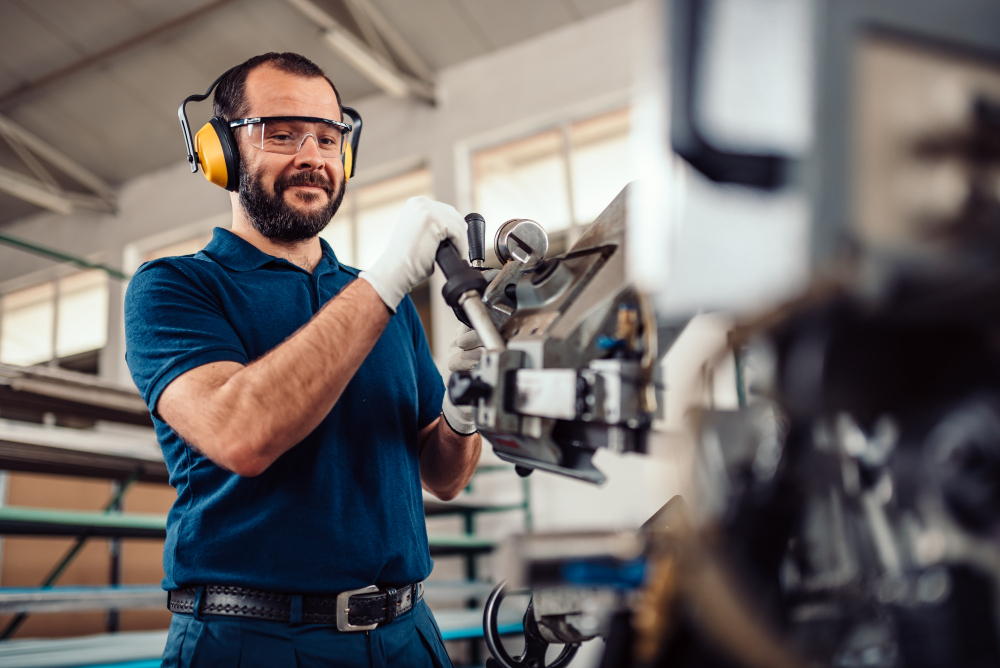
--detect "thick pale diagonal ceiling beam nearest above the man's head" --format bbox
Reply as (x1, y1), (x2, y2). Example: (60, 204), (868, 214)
(286, 0), (435, 104)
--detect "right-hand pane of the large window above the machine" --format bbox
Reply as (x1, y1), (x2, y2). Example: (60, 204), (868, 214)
(570, 109), (635, 225)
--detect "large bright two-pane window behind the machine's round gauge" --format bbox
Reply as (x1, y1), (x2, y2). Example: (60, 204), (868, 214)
(472, 108), (634, 252)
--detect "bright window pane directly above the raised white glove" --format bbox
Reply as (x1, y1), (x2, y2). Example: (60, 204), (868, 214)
(356, 169), (433, 269)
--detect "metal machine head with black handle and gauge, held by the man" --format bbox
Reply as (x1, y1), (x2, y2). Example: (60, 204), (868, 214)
(439, 188), (658, 483)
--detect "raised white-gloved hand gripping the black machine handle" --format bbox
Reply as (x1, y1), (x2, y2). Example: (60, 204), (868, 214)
(360, 197), (469, 313)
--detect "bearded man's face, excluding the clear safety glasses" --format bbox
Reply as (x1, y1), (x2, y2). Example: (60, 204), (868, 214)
(234, 65), (346, 242)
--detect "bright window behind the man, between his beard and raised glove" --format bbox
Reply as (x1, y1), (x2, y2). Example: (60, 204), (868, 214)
(320, 168), (434, 341)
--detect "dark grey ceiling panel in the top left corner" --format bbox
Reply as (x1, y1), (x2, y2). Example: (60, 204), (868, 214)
(0, 3), (82, 81)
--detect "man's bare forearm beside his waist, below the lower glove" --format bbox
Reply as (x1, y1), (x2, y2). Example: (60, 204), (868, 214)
(419, 417), (483, 501)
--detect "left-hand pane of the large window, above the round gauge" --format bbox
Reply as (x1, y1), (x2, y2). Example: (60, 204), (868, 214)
(472, 129), (570, 240)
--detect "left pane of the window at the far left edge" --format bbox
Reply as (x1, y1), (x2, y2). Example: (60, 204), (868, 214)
(0, 283), (55, 366)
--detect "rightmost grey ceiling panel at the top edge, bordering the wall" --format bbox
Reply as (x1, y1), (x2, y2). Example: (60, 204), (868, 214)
(455, 0), (578, 48)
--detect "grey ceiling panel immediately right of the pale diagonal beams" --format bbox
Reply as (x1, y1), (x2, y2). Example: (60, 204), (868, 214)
(372, 0), (492, 70)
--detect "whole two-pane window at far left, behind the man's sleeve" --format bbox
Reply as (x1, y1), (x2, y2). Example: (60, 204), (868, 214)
(0, 270), (108, 373)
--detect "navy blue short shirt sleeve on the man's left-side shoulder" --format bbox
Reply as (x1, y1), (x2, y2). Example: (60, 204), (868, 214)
(125, 260), (249, 414)
